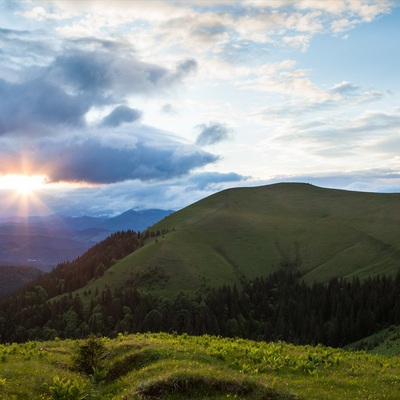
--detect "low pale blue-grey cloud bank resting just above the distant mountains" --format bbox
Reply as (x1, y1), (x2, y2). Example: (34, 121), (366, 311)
(35, 172), (248, 215)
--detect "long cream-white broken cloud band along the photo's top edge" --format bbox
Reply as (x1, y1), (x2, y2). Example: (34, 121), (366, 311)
(21, 0), (392, 58)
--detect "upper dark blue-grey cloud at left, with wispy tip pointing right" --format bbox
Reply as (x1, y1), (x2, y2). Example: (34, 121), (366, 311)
(0, 35), (197, 136)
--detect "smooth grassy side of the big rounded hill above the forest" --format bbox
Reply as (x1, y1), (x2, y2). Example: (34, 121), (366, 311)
(79, 183), (400, 295)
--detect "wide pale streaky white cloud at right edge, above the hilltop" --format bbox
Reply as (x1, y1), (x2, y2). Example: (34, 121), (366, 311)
(273, 110), (400, 162)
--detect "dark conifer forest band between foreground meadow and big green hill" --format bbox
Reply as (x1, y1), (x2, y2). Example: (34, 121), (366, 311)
(0, 267), (400, 347)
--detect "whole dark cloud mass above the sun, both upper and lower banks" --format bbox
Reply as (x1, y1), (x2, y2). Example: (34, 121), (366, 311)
(0, 30), (219, 184)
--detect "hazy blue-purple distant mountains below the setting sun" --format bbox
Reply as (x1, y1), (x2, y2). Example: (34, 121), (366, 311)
(0, 209), (173, 275)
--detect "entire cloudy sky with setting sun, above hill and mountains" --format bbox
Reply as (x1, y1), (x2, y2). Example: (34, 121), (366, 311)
(0, 0), (400, 216)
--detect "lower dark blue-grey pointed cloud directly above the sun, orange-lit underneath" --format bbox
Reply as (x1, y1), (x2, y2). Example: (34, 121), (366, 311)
(0, 126), (219, 184)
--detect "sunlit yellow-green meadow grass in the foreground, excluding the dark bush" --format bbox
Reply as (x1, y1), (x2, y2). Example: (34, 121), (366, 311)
(0, 333), (400, 400)
